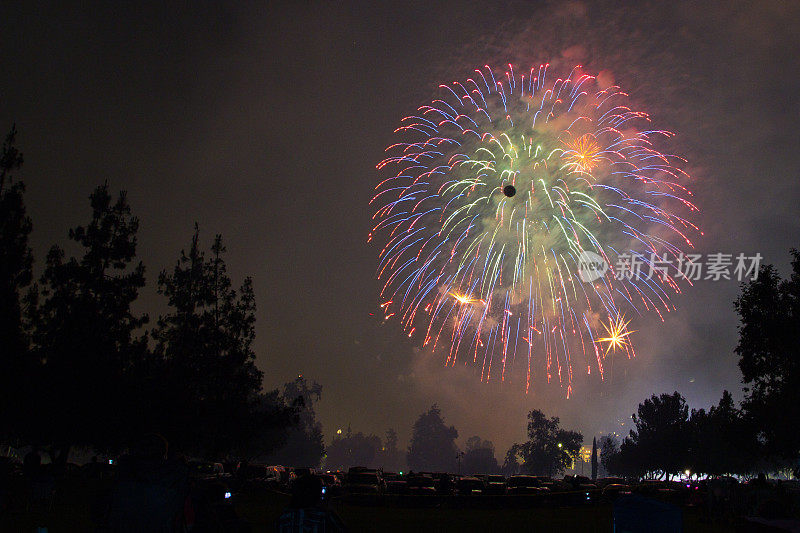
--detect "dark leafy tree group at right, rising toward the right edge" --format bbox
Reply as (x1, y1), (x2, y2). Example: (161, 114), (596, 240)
(600, 249), (800, 478)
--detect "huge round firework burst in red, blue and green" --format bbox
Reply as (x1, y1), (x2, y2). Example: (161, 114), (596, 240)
(369, 65), (698, 396)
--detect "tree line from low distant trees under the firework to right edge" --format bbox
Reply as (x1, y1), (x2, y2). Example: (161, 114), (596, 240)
(328, 250), (800, 479)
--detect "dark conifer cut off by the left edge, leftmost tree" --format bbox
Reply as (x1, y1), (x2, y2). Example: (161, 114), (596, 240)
(0, 126), (33, 438)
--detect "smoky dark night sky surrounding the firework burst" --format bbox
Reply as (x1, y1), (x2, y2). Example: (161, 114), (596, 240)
(0, 1), (800, 457)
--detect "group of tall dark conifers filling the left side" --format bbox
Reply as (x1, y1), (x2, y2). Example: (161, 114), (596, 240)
(0, 128), (324, 465)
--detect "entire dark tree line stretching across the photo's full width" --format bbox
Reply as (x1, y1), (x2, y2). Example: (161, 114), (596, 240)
(0, 123), (800, 477)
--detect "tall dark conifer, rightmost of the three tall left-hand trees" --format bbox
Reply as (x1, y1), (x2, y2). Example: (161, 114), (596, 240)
(153, 225), (268, 458)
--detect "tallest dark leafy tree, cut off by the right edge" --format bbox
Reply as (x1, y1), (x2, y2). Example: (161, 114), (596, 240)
(735, 249), (800, 474)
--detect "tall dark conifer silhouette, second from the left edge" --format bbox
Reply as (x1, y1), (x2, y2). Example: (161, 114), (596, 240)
(29, 184), (147, 462)
